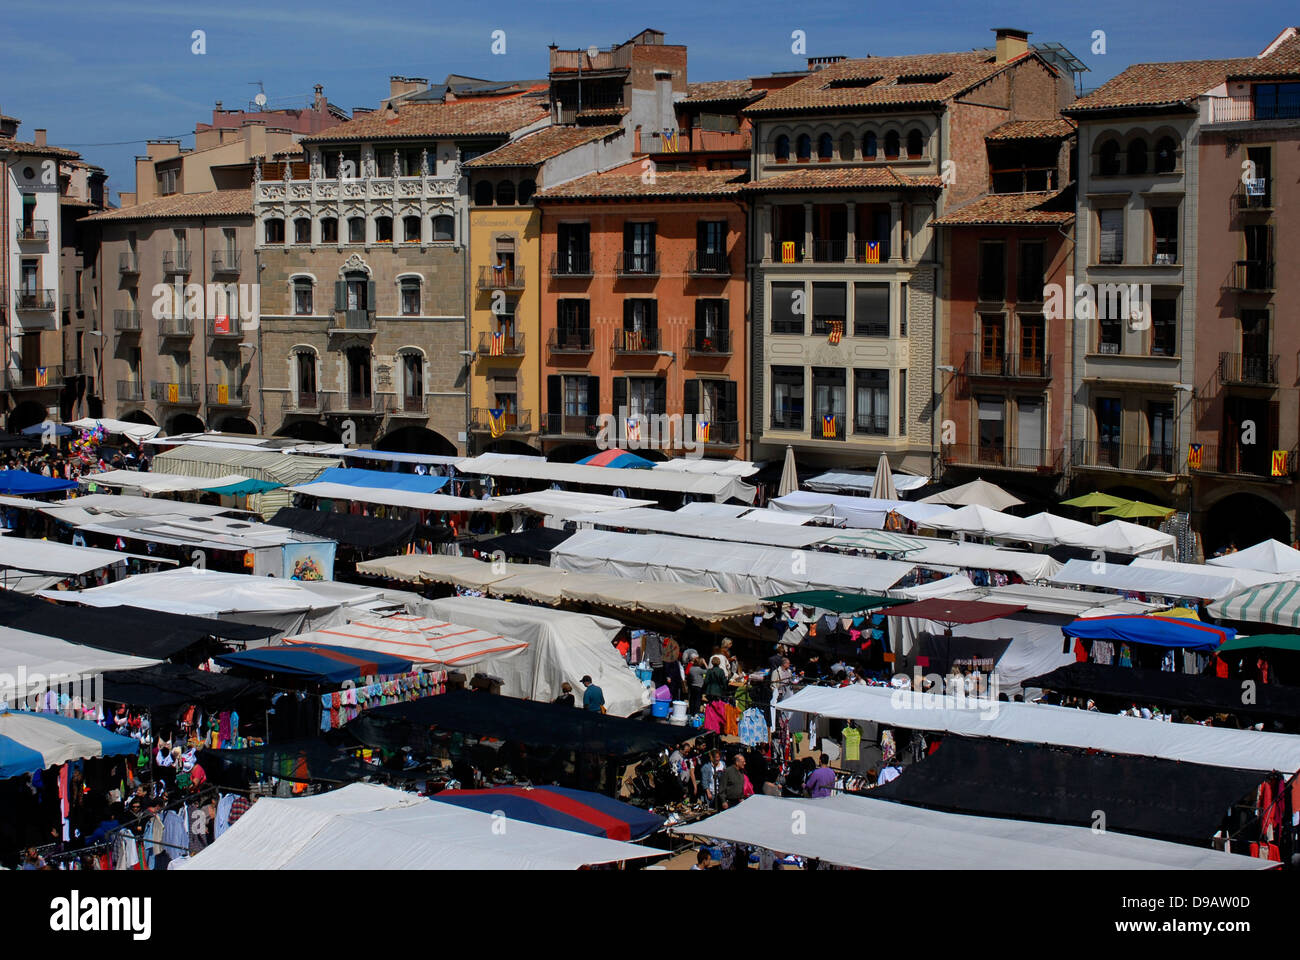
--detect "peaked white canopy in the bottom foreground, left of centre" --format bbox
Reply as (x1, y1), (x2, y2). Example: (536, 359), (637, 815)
(173, 783), (663, 870)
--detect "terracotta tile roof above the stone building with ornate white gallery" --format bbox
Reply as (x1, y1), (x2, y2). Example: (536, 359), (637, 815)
(299, 96), (550, 143)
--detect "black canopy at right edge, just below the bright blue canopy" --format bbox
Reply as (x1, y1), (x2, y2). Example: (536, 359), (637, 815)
(1021, 663), (1300, 721)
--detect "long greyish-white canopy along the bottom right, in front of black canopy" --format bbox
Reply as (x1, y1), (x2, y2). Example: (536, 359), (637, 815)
(670, 795), (1274, 870)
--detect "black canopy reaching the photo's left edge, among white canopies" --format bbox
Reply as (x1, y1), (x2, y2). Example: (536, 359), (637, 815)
(0, 591), (277, 660)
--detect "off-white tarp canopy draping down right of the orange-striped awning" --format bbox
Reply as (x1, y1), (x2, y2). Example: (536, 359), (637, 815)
(417, 597), (650, 717)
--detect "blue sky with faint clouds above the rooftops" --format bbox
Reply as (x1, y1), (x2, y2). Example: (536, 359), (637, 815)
(0, 0), (1300, 198)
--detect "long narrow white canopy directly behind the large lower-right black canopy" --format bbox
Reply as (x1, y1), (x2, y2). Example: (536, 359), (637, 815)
(777, 686), (1300, 774)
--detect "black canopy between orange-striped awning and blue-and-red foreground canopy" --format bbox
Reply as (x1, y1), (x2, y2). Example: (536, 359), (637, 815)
(347, 689), (703, 757)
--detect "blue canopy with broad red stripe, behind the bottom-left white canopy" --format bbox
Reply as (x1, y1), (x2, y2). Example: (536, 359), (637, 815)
(429, 787), (663, 840)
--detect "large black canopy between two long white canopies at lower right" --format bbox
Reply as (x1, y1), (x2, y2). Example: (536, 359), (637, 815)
(871, 736), (1264, 844)
